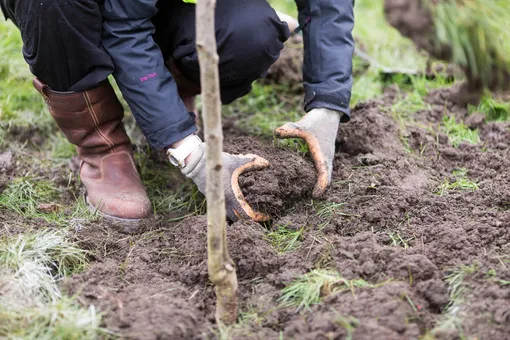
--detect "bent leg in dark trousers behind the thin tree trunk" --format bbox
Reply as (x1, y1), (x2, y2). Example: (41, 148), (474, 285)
(154, 0), (290, 104)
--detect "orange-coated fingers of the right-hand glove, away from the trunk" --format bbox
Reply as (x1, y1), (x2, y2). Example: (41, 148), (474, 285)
(275, 122), (329, 198)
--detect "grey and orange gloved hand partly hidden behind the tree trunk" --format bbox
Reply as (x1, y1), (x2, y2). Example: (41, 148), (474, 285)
(181, 143), (270, 222)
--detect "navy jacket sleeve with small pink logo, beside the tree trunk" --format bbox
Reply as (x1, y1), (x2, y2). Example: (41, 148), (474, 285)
(101, 0), (196, 149)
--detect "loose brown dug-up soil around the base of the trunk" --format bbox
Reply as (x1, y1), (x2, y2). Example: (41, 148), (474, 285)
(0, 84), (510, 340)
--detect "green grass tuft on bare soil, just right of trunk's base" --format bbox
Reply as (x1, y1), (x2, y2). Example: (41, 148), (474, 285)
(279, 269), (373, 310)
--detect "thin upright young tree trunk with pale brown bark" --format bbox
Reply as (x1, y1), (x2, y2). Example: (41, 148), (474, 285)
(196, 0), (237, 324)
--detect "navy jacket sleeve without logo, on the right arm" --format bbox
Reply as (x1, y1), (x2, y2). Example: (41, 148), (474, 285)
(296, 0), (354, 122)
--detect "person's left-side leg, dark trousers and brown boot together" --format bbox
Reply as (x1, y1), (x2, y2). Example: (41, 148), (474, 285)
(8, 0), (151, 219)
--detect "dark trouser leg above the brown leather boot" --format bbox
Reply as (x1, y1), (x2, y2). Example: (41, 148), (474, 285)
(14, 0), (114, 92)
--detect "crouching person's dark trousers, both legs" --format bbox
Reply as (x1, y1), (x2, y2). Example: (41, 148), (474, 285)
(5, 0), (289, 104)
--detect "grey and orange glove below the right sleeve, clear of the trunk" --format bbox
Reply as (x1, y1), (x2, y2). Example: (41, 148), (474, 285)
(275, 109), (343, 197)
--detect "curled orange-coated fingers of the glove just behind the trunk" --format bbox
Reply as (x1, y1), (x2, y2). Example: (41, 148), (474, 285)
(229, 154), (270, 222)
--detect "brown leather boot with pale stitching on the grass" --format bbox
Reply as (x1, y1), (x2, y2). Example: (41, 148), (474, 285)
(34, 78), (151, 221)
